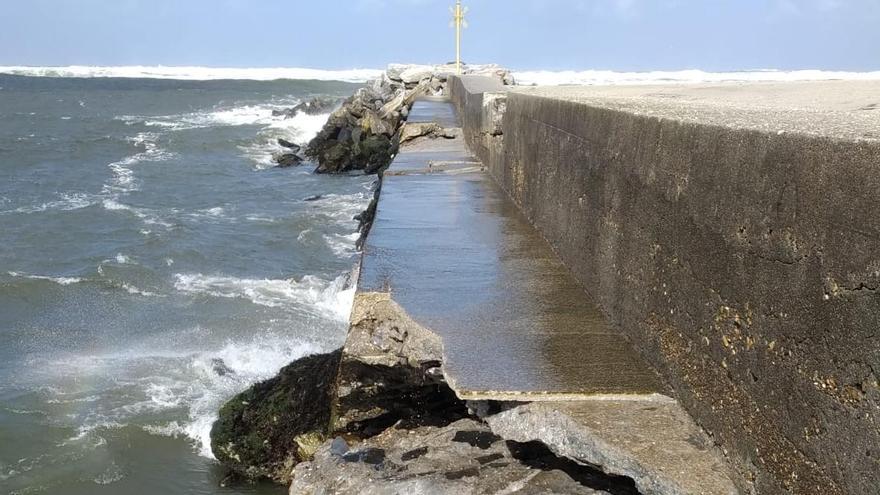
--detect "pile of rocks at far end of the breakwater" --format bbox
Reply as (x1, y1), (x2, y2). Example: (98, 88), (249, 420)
(305, 65), (513, 174)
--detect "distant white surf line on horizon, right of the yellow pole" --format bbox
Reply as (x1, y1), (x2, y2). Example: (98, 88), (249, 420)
(513, 70), (880, 86)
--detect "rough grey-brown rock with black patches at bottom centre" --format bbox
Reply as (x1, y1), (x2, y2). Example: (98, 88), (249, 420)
(290, 419), (622, 495)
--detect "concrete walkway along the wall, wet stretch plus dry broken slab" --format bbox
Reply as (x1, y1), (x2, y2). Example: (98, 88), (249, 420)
(350, 99), (738, 494)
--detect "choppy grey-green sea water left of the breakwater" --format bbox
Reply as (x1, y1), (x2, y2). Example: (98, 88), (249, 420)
(0, 75), (372, 494)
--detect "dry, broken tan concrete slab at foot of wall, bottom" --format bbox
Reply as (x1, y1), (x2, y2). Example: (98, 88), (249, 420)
(486, 399), (740, 495)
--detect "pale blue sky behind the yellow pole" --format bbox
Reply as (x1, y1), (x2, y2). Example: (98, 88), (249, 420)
(0, 0), (880, 71)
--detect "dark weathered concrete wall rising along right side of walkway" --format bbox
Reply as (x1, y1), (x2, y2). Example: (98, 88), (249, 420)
(450, 75), (880, 494)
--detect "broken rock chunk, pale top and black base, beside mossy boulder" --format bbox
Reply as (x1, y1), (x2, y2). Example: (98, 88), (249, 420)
(333, 292), (467, 436)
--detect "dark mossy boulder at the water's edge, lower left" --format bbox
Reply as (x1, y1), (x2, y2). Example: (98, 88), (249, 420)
(211, 351), (342, 483)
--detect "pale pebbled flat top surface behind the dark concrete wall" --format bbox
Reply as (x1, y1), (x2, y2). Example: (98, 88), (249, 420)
(513, 81), (880, 141)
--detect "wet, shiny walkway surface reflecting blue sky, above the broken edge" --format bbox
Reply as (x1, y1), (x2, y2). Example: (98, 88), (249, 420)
(359, 99), (661, 400)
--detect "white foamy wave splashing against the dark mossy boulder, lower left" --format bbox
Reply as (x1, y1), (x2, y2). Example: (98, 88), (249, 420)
(46, 332), (323, 458)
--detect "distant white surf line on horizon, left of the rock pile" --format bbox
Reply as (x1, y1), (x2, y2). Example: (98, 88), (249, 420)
(0, 65), (382, 82)
